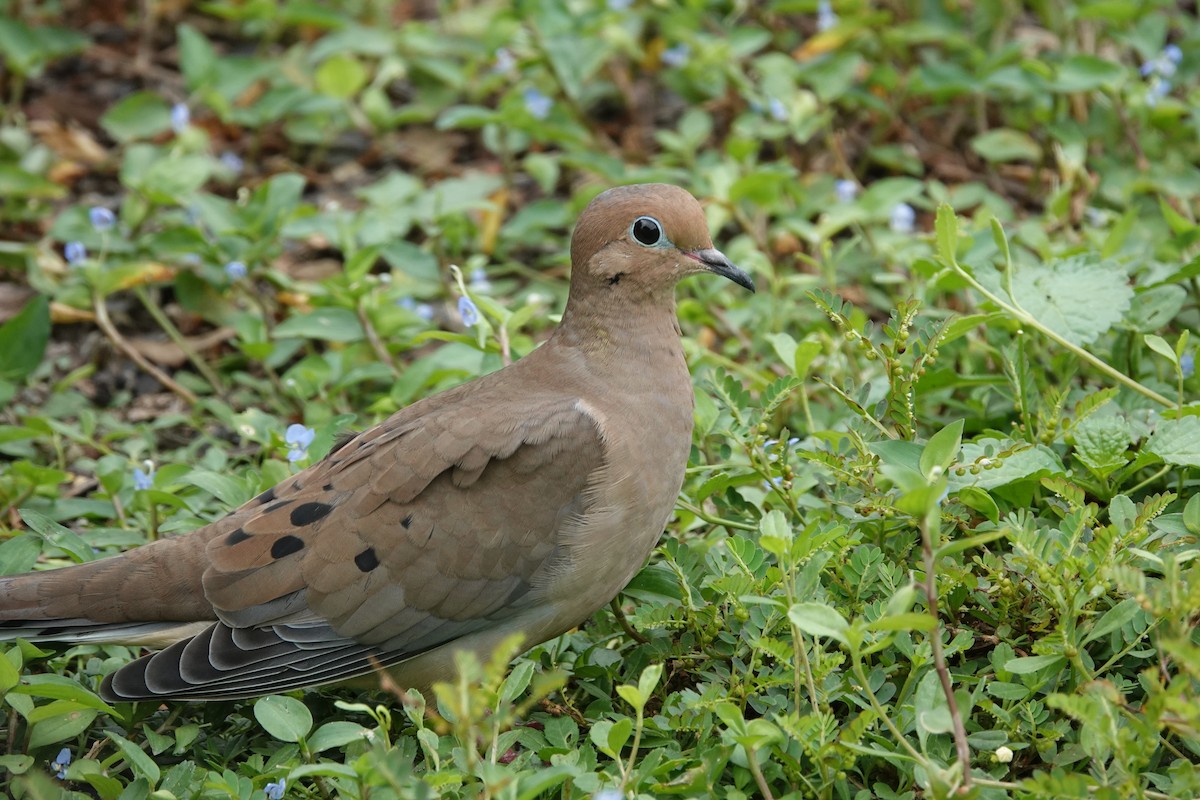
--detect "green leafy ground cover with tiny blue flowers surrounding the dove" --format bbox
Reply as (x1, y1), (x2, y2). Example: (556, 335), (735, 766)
(0, 0), (1200, 800)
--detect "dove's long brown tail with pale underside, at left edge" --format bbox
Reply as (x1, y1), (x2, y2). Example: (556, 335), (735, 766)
(0, 531), (216, 646)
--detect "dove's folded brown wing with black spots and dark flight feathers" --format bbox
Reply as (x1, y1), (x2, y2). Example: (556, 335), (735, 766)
(104, 387), (605, 699)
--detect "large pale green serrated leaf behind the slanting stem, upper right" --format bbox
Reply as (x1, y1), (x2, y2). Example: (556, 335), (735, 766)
(1013, 255), (1133, 345)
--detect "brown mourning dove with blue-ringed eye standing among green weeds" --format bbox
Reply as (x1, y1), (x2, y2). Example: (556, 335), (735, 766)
(0, 185), (754, 700)
